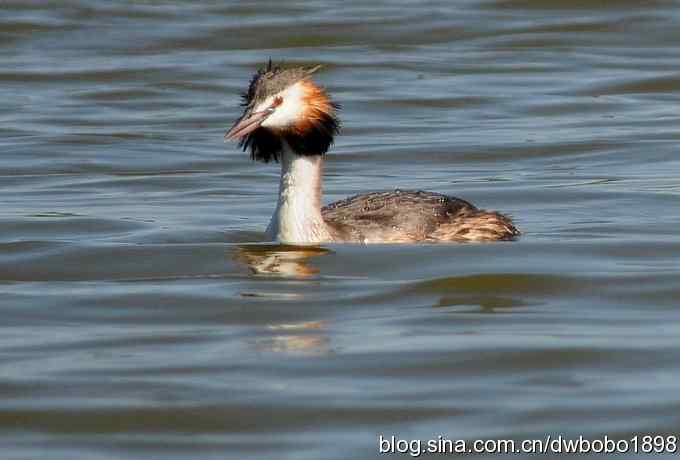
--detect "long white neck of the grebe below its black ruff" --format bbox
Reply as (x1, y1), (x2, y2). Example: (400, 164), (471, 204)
(267, 142), (331, 244)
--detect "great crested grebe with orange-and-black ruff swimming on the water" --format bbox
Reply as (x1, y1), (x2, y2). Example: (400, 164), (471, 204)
(225, 60), (519, 244)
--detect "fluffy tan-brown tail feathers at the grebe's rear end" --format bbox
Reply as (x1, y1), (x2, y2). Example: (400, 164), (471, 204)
(428, 209), (520, 242)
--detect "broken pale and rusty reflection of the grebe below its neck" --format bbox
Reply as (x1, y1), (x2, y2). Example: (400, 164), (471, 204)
(235, 244), (332, 356)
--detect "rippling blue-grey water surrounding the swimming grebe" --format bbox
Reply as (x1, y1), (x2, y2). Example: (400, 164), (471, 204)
(0, 0), (680, 460)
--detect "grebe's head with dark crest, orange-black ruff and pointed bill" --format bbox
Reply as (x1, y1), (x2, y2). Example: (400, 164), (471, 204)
(225, 60), (340, 163)
